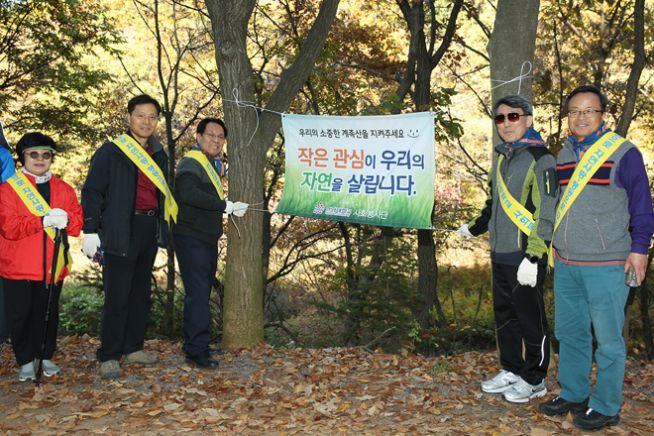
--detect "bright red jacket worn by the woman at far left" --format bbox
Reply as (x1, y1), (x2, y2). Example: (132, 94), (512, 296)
(0, 174), (84, 283)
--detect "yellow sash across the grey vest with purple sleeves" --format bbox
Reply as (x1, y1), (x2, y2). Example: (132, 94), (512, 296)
(549, 132), (626, 267)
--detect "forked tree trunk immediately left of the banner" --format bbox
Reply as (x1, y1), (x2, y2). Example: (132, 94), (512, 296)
(205, 0), (339, 348)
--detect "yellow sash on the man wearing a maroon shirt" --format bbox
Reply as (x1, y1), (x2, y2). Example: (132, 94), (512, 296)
(112, 134), (179, 223)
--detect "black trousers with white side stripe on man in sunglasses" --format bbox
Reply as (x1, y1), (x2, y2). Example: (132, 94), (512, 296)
(493, 263), (550, 384)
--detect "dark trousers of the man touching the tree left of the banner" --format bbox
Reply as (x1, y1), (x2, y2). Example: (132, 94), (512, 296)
(174, 234), (218, 356)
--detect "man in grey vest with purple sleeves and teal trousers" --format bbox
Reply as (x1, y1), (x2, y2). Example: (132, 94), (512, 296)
(539, 85), (654, 430)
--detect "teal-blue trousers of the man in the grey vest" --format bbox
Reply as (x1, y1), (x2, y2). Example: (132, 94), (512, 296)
(554, 260), (629, 416)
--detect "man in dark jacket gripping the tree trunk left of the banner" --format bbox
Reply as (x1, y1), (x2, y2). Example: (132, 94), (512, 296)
(173, 118), (248, 369)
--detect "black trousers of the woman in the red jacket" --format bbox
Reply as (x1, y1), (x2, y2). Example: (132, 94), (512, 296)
(3, 279), (63, 365)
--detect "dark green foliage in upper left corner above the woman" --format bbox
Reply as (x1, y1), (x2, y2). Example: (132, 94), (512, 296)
(0, 0), (120, 142)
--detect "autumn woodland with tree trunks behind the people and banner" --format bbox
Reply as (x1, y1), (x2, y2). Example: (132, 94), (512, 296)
(0, 0), (654, 360)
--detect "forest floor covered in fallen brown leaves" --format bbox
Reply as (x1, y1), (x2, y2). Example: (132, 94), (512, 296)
(0, 337), (654, 435)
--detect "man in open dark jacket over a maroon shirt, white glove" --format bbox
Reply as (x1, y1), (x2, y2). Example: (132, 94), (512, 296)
(82, 95), (174, 378)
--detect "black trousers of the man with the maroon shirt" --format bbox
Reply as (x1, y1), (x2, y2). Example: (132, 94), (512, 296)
(97, 215), (157, 362)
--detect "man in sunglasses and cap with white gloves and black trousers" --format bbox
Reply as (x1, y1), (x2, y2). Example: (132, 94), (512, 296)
(457, 95), (557, 403)
